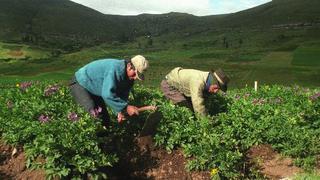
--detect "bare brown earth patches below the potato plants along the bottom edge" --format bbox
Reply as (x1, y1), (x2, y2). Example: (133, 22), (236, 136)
(0, 137), (312, 180)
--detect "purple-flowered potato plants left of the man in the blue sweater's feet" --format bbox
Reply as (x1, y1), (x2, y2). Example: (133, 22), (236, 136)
(0, 82), (117, 178)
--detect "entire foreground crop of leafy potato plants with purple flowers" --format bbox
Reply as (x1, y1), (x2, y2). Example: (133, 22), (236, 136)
(0, 81), (320, 179)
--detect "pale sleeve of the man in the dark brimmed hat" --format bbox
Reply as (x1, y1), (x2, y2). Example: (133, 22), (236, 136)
(190, 80), (208, 115)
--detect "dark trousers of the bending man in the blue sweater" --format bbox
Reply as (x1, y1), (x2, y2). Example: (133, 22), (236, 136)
(69, 77), (110, 127)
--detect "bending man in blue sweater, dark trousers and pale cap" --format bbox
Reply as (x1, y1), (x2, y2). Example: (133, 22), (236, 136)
(70, 55), (148, 125)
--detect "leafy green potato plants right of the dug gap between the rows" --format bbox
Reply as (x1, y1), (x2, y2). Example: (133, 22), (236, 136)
(155, 85), (320, 178)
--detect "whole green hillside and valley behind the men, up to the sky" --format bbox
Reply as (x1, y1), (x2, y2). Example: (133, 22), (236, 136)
(0, 0), (320, 87)
